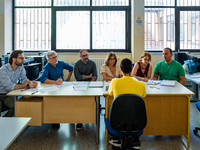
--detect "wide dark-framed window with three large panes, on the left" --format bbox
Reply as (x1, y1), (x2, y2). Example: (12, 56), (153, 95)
(13, 0), (131, 52)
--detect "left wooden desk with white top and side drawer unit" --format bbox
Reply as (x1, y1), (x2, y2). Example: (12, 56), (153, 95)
(7, 83), (103, 144)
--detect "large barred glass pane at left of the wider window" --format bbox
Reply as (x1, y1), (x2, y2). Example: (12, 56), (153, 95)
(14, 8), (51, 50)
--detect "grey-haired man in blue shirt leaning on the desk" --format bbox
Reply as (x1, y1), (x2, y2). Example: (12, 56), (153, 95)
(40, 51), (74, 84)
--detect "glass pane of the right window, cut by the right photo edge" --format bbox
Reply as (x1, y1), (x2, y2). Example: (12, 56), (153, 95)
(180, 11), (200, 49)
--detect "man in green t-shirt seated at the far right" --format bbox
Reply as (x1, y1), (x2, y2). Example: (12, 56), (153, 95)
(153, 47), (185, 85)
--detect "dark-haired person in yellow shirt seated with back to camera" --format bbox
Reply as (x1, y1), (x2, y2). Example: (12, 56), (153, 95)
(108, 58), (146, 149)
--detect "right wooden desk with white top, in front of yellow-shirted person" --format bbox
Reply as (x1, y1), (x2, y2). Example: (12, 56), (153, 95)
(104, 82), (194, 145)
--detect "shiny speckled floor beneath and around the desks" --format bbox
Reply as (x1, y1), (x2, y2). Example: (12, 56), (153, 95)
(8, 96), (200, 150)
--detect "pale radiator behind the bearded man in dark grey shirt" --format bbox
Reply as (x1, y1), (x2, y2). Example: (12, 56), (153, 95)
(70, 58), (105, 81)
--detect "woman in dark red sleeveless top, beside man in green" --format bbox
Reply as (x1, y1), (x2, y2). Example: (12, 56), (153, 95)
(132, 52), (152, 81)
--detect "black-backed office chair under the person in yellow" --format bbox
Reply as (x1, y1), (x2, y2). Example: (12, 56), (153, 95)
(105, 94), (147, 149)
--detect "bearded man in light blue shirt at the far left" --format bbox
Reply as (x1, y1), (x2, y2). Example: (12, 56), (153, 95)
(0, 50), (37, 117)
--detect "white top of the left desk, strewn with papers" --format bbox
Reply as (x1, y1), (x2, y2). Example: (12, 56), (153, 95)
(7, 81), (103, 97)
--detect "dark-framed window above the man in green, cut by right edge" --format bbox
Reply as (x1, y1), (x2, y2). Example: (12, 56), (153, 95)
(145, 0), (200, 52)
